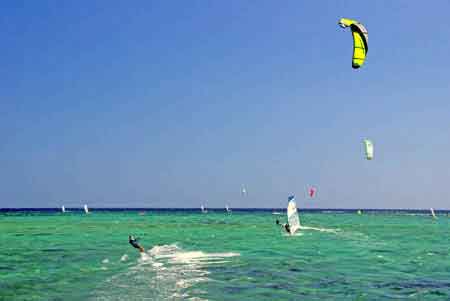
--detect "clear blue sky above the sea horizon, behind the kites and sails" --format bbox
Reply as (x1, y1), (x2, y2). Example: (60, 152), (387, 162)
(0, 0), (450, 209)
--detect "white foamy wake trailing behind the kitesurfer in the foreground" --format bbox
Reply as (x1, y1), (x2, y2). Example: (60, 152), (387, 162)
(93, 244), (240, 300)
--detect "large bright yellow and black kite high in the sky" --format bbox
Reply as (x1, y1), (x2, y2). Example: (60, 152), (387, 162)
(339, 18), (369, 69)
